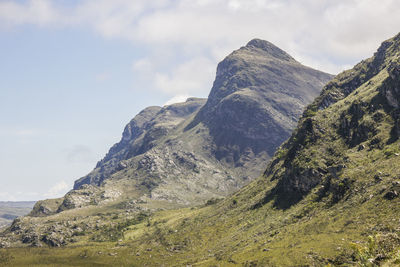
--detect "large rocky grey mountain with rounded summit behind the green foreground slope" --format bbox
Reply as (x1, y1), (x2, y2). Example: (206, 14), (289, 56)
(32, 39), (332, 216)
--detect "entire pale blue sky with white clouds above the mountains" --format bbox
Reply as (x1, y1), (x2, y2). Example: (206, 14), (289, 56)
(0, 0), (400, 201)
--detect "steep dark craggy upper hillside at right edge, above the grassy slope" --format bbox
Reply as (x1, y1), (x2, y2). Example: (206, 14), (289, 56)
(265, 34), (400, 208)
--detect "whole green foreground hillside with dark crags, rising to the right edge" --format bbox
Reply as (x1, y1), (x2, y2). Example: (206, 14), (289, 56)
(2, 34), (400, 266)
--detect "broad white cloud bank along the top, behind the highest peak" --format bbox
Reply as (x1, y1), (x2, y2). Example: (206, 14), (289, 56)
(0, 0), (400, 89)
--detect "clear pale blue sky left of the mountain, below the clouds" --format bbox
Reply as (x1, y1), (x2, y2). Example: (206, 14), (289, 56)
(0, 25), (169, 200)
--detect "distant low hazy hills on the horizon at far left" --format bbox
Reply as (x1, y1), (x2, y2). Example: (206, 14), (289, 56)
(0, 201), (35, 228)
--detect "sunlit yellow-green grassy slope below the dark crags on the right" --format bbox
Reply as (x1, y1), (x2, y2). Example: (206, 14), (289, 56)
(3, 73), (400, 266)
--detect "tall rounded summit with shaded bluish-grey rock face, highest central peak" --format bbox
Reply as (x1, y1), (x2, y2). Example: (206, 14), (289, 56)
(191, 39), (331, 165)
